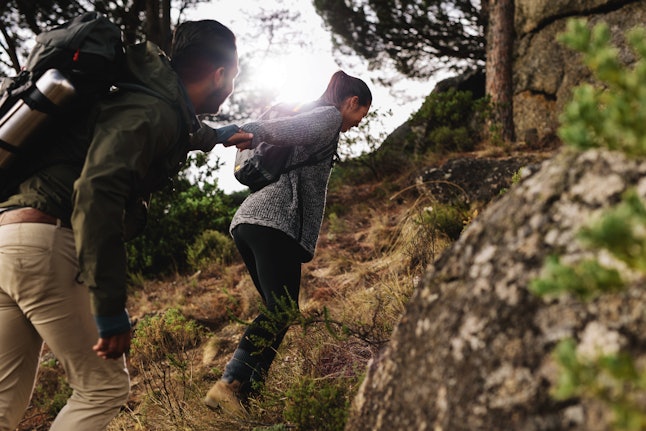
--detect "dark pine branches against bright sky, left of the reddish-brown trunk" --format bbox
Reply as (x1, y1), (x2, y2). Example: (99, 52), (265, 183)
(314, 0), (487, 78)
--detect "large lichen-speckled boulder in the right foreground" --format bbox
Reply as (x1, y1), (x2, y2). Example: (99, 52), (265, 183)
(346, 150), (646, 431)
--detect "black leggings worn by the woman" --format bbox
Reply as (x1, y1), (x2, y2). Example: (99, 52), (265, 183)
(233, 224), (303, 382)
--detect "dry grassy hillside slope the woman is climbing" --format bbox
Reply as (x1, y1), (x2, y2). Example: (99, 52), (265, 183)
(19, 146), (550, 431)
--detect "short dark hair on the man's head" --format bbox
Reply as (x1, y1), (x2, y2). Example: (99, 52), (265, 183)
(170, 19), (237, 81)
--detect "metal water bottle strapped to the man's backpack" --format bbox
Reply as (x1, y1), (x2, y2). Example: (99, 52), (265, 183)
(0, 69), (76, 169)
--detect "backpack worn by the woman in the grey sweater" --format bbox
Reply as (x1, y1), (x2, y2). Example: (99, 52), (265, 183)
(233, 105), (338, 192)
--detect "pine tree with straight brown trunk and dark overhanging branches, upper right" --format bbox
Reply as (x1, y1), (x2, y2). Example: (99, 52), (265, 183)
(314, 0), (514, 145)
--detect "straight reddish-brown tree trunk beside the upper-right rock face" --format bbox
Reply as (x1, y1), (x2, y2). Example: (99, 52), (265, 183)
(486, 0), (514, 142)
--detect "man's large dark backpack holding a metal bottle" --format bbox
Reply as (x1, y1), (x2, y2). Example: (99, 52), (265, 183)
(0, 12), (125, 191)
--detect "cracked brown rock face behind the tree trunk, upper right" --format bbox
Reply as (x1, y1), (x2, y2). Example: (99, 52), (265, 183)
(513, 0), (646, 145)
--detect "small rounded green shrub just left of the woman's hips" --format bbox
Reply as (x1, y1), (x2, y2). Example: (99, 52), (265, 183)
(186, 230), (236, 271)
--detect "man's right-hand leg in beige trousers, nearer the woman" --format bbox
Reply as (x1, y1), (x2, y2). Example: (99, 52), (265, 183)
(4, 223), (130, 431)
